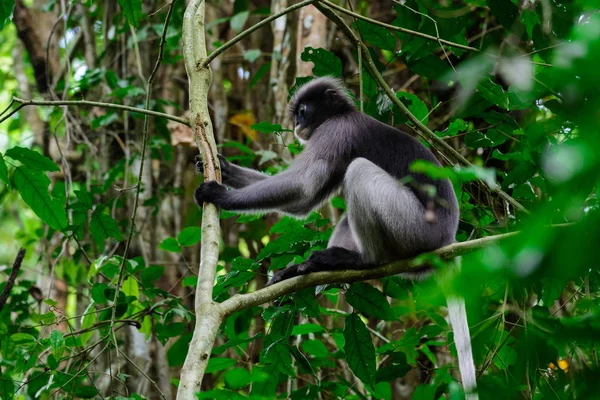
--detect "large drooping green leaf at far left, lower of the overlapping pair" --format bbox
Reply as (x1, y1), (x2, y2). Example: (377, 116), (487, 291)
(13, 166), (67, 231)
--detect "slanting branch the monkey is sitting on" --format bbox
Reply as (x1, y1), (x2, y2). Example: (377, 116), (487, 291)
(221, 232), (520, 316)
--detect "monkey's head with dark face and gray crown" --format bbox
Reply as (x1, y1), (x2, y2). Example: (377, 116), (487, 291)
(289, 76), (355, 143)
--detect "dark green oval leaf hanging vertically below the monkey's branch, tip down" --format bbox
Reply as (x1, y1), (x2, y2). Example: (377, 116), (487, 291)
(344, 314), (376, 387)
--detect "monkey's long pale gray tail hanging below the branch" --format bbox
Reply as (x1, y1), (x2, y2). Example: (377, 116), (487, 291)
(447, 296), (479, 400)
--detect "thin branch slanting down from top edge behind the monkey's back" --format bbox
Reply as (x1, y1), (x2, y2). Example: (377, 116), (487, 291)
(315, 1), (529, 214)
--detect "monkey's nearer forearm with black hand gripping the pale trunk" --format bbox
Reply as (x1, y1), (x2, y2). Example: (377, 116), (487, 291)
(194, 160), (335, 215)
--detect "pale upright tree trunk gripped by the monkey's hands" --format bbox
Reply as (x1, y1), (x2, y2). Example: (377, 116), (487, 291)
(177, 0), (223, 399)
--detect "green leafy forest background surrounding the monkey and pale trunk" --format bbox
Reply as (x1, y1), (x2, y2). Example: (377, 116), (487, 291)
(0, 0), (600, 400)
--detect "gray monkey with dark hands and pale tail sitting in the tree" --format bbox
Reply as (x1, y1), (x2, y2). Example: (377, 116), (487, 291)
(194, 78), (477, 399)
